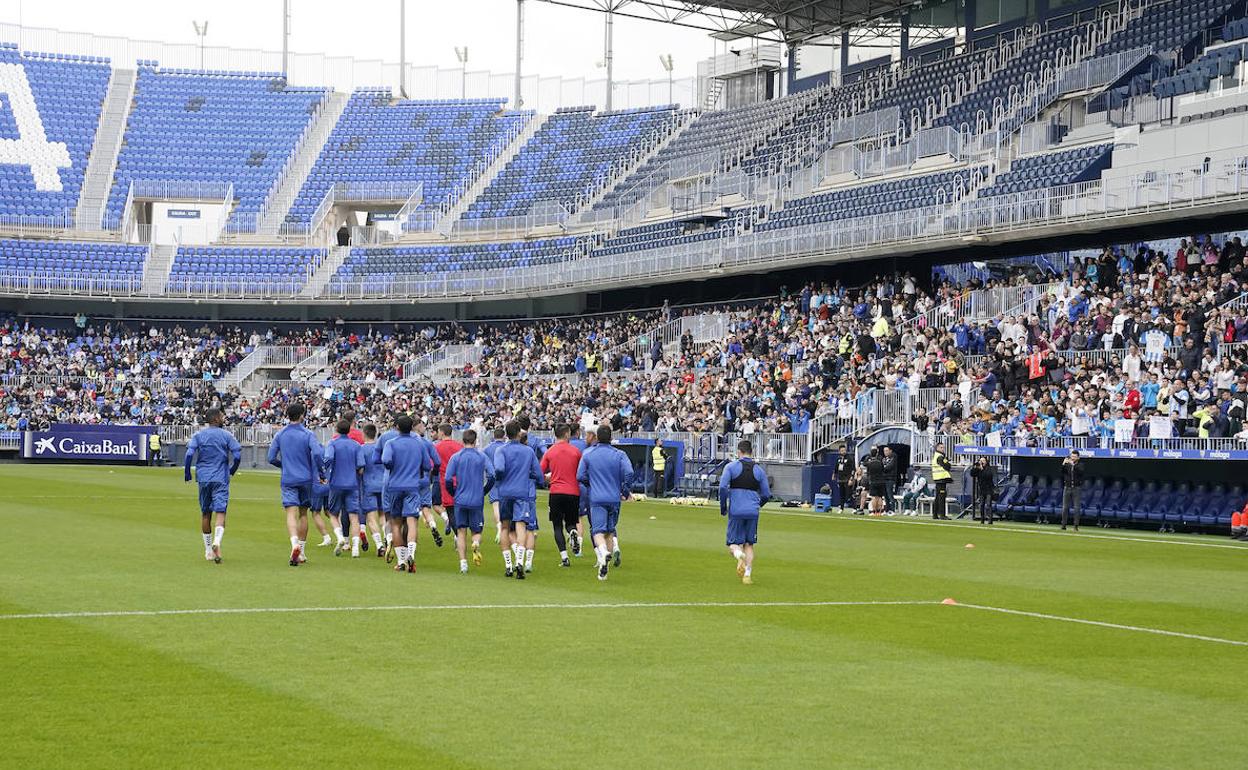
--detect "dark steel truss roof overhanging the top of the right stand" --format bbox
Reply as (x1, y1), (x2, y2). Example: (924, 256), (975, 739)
(543, 0), (924, 42)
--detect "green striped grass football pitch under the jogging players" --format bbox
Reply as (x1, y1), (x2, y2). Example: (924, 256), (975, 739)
(0, 465), (1248, 770)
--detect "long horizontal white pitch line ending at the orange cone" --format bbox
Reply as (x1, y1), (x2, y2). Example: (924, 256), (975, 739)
(0, 599), (940, 620)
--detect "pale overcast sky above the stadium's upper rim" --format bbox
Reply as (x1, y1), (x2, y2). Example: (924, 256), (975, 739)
(0, 0), (714, 80)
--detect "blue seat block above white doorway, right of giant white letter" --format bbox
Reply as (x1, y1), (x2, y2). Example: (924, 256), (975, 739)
(107, 66), (326, 222)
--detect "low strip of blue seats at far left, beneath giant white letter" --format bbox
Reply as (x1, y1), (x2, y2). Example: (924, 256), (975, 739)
(0, 238), (147, 285)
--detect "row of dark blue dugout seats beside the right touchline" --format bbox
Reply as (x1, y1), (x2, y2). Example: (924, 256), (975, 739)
(992, 474), (1248, 529)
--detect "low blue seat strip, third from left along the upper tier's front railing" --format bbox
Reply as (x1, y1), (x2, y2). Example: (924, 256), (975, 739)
(329, 236), (582, 291)
